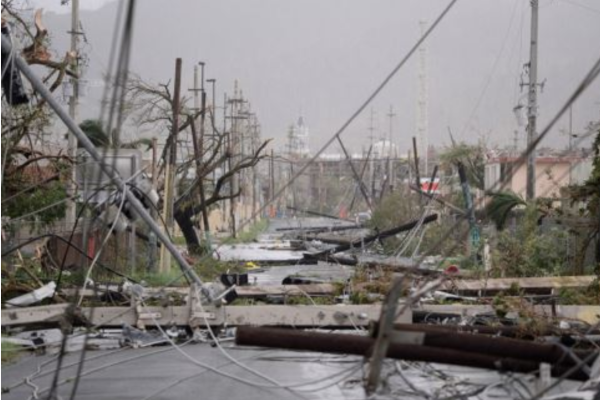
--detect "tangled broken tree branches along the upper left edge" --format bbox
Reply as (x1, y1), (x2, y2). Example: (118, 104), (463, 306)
(2, 7), (77, 222)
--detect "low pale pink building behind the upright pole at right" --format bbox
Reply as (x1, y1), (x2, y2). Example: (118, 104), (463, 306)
(485, 155), (592, 198)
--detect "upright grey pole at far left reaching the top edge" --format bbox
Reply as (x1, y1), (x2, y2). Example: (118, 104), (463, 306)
(66, 0), (81, 225)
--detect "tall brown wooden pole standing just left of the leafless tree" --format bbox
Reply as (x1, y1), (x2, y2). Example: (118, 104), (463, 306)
(160, 58), (182, 272)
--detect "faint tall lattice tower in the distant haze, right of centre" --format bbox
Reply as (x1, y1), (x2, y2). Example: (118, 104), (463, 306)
(417, 21), (429, 175)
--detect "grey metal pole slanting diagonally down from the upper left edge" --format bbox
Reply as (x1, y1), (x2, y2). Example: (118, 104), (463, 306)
(2, 37), (206, 299)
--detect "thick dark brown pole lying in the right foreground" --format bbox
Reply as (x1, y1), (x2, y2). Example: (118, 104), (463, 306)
(235, 326), (589, 381)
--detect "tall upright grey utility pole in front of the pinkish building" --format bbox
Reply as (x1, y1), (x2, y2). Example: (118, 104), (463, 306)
(527, 0), (539, 200)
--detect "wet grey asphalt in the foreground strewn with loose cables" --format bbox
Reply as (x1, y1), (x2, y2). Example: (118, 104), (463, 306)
(2, 344), (579, 400)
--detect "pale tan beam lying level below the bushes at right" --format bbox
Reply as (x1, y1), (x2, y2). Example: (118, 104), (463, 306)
(443, 275), (596, 291)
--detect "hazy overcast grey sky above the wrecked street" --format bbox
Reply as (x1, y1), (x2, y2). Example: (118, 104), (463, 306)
(34, 0), (600, 155)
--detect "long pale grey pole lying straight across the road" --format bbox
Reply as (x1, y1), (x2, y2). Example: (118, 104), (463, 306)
(2, 304), (412, 329)
